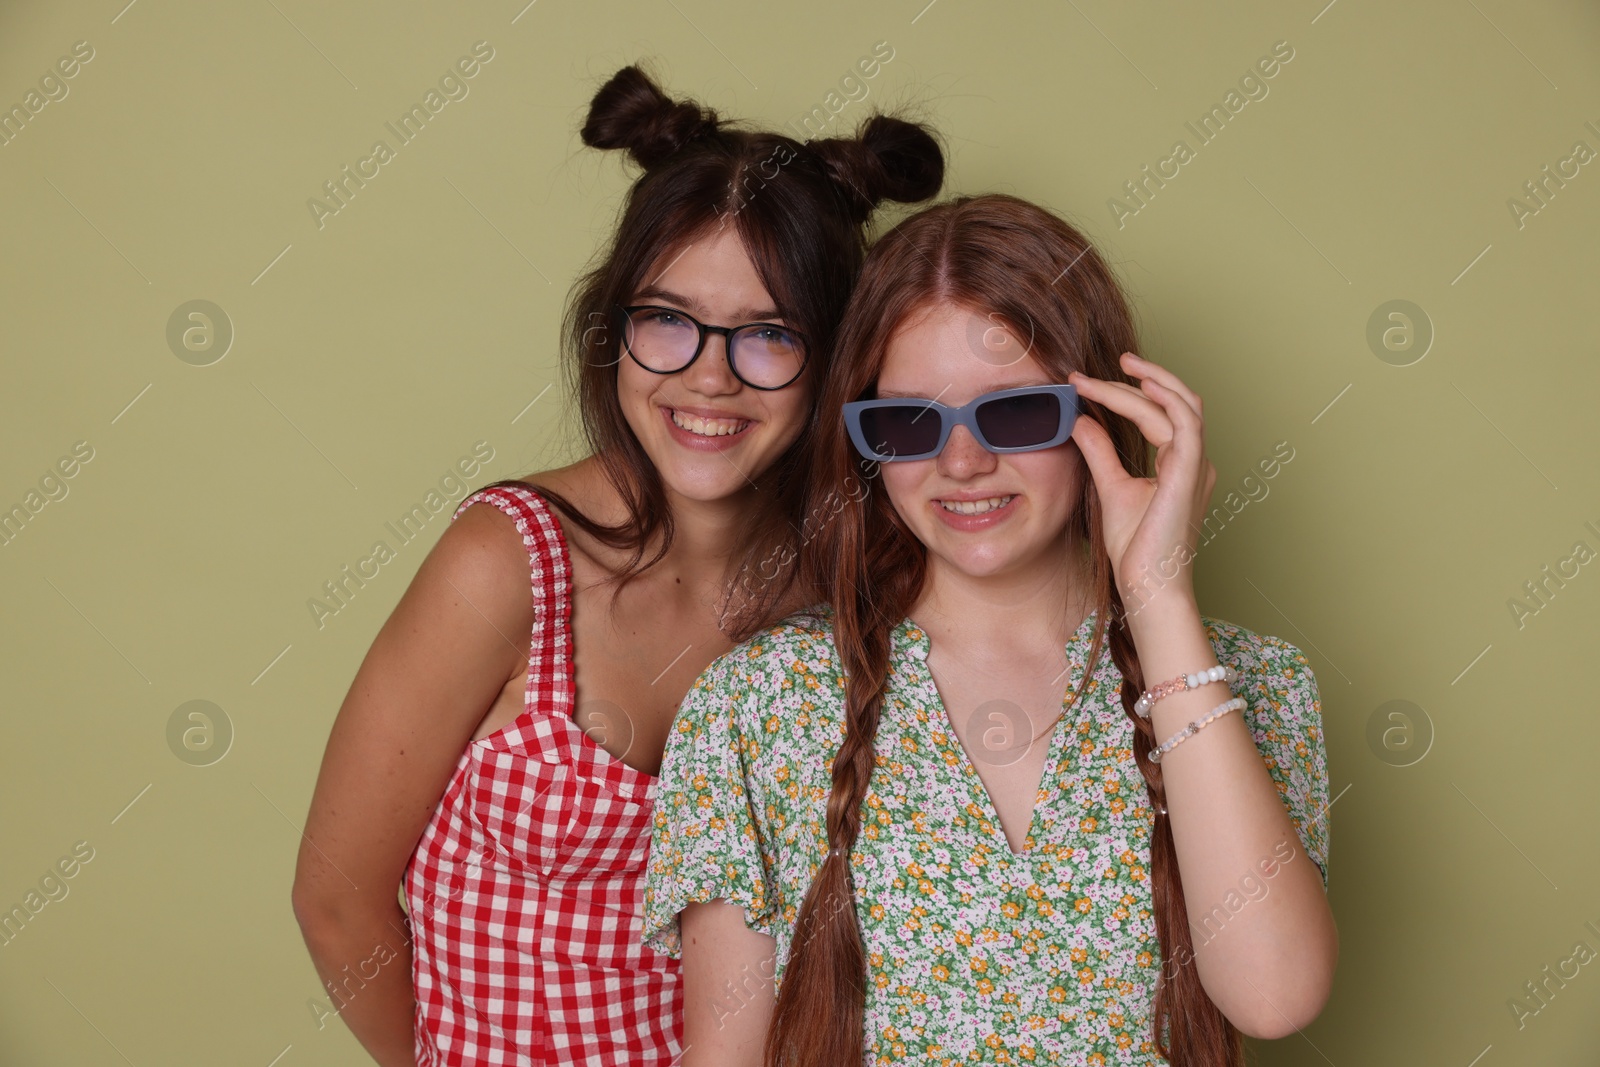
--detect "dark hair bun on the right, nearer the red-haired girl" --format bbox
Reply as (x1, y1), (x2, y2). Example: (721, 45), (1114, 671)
(806, 115), (944, 219)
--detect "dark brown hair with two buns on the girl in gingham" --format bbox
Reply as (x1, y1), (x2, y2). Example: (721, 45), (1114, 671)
(480, 66), (944, 613)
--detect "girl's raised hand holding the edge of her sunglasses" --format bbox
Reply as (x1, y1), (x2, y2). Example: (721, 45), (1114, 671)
(1067, 352), (1216, 613)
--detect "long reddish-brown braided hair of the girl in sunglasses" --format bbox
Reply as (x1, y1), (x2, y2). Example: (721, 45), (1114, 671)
(766, 195), (1242, 1067)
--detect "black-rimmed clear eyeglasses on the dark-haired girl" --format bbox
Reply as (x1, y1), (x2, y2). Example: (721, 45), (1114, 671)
(618, 304), (806, 389)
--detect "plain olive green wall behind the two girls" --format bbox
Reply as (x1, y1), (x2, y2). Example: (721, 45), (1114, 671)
(0, 0), (1600, 1067)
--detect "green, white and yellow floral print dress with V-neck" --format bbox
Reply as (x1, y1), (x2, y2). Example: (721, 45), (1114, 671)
(643, 608), (1328, 1065)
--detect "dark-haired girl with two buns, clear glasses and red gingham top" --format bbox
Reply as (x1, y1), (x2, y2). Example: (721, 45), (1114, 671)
(294, 67), (942, 1065)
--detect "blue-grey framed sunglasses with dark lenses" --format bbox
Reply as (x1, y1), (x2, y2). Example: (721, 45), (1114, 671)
(845, 386), (1078, 462)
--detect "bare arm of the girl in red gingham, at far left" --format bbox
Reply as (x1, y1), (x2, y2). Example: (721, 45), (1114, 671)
(293, 502), (533, 1067)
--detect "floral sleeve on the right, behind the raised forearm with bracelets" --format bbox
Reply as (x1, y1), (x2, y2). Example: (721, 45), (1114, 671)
(1218, 624), (1330, 893)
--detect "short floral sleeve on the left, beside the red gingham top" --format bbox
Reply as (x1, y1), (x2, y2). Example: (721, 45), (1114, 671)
(643, 649), (782, 957)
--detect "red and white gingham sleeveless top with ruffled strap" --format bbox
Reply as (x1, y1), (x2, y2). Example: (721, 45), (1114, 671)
(405, 486), (682, 1067)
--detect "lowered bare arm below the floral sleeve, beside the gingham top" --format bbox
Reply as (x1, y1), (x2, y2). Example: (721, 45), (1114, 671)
(678, 901), (778, 1067)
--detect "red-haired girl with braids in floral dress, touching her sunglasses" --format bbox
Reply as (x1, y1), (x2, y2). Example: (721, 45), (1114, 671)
(645, 195), (1338, 1067)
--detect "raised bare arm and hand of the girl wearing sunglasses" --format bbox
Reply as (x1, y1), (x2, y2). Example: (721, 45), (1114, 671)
(1067, 352), (1339, 1038)
